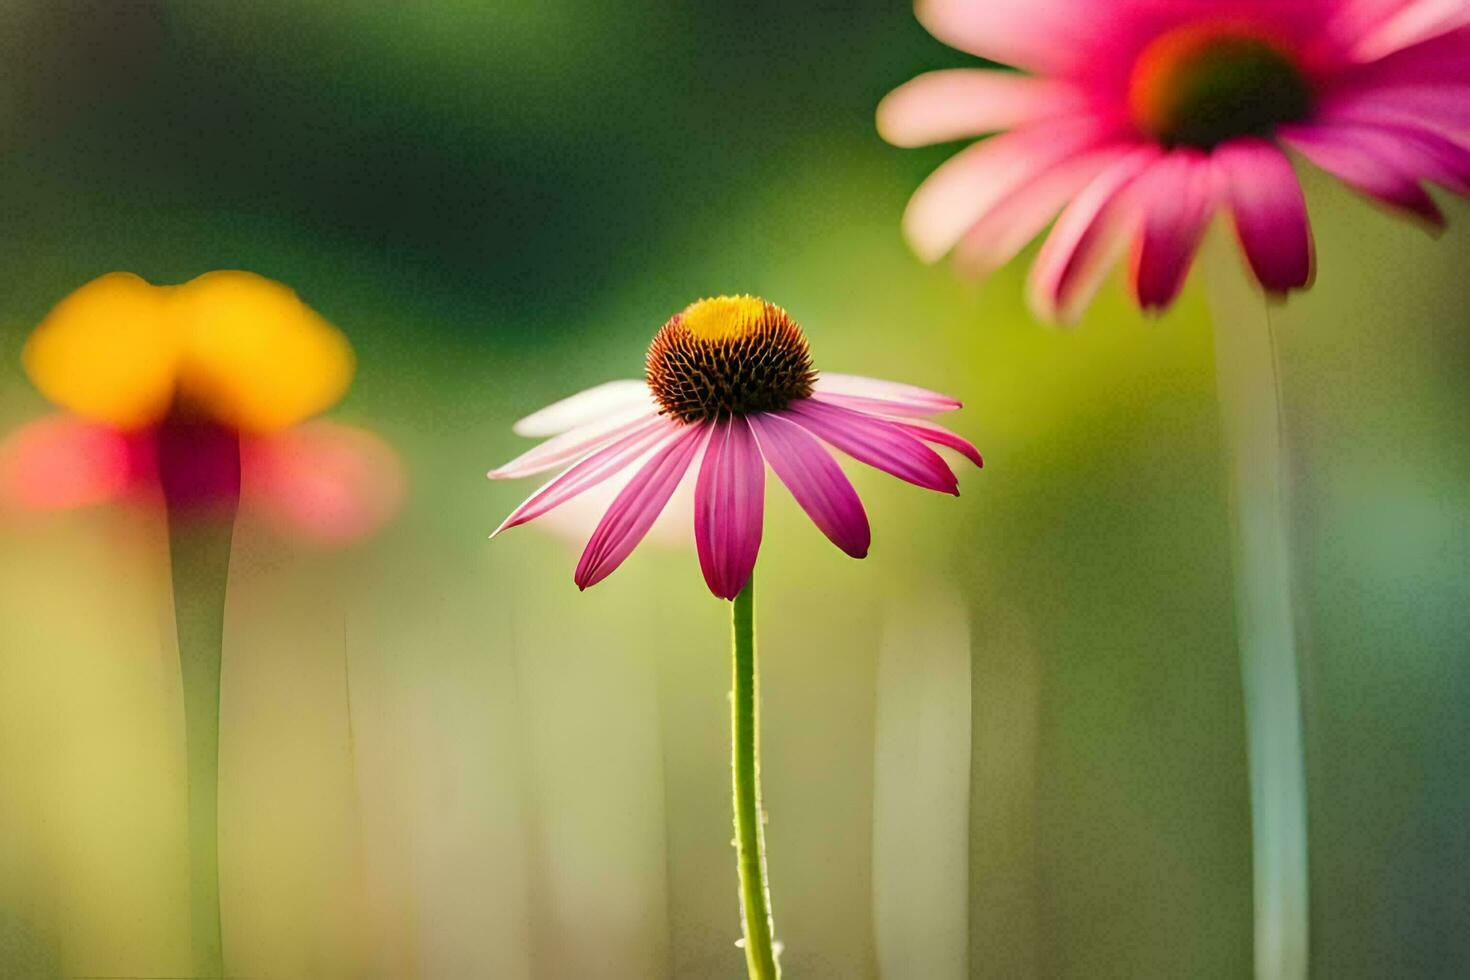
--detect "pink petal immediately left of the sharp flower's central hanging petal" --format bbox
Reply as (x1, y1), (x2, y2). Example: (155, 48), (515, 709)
(573, 425), (711, 589)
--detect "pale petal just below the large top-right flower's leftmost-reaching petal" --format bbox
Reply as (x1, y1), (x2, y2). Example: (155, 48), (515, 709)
(904, 122), (1111, 262)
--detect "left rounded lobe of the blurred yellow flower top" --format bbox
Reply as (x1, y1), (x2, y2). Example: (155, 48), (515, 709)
(22, 272), (179, 429)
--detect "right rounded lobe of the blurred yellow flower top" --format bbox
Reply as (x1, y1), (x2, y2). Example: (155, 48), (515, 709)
(175, 272), (354, 432)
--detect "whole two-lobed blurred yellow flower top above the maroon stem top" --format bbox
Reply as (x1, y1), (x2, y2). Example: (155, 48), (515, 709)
(24, 272), (354, 433)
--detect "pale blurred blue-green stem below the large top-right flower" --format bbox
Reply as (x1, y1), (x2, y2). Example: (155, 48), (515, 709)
(1207, 235), (1308, 980)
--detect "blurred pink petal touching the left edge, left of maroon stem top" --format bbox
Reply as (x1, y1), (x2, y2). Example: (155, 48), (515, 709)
(0, 414), (151, 510)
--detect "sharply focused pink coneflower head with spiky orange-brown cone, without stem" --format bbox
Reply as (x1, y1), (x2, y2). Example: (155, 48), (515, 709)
(490, 297), (982, 599)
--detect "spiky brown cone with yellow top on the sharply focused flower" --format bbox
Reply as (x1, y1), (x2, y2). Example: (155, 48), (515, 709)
(647, 295), (816, 422)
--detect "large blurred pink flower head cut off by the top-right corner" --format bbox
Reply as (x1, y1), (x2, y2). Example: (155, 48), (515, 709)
(878, 0), (1470, 320)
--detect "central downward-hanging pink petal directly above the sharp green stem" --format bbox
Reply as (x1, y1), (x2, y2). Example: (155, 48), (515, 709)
(694, 416), (766, 599)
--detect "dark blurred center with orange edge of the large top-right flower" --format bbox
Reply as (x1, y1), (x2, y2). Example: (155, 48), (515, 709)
(1129, 24), (1313, 150)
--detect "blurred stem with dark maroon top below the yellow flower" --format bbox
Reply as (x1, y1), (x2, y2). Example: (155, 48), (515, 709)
(159, 419), (240, 977)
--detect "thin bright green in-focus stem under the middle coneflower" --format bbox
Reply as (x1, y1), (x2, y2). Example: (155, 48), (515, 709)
(731, 574), (781, 980)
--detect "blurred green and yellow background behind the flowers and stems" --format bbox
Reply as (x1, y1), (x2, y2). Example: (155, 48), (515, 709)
(0, 0), (1470, 980)
